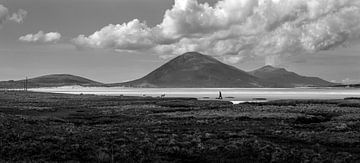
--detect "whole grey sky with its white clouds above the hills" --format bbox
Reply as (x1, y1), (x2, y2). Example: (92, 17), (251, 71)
(0, 0), (360, 83)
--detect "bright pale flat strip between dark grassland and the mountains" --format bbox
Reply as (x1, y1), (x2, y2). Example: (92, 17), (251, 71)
(30, 86), (360, 102)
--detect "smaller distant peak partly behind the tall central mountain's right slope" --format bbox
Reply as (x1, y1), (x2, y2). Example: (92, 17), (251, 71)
(249, 66), (335, 87)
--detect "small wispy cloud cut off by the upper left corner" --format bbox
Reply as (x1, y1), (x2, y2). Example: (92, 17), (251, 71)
(0, 4), (27, 25)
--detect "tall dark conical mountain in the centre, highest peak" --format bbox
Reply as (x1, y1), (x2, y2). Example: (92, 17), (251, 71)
(111, 52), (272, 88)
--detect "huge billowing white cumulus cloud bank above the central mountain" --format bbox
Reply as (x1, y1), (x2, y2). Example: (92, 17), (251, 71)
(74, 0), (360, 64)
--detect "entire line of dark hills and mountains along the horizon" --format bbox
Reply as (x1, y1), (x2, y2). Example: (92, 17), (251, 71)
(0, 52), (335, 88)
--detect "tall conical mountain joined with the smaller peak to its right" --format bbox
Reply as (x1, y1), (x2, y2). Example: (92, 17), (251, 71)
(114, 52), (331, 88)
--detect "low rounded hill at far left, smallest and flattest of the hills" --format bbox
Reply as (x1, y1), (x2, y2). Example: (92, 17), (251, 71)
(0, 74), (103, 88)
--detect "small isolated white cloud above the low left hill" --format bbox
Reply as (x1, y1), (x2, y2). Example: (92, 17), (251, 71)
(19, 31), (61, 43)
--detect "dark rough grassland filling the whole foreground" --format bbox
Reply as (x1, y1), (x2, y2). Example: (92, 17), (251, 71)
(0, 92), (360, 162)
